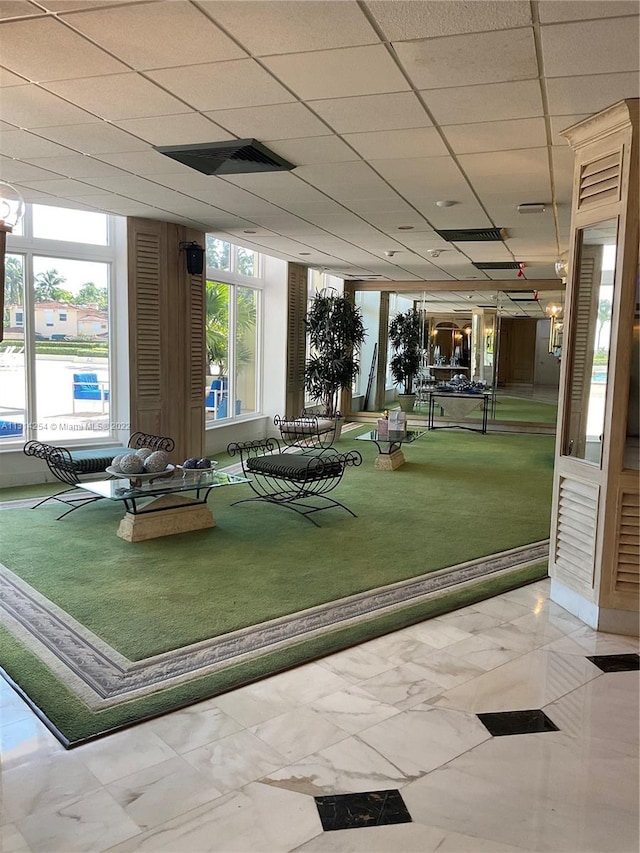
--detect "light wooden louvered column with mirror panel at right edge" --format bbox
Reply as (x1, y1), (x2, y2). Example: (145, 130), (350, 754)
(550, 99), (640, 634)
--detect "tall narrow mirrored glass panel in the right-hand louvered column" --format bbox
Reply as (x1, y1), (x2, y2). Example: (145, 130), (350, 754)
(566, 220), (616, 465)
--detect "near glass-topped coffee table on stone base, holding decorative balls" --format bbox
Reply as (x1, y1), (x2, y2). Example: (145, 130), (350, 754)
(78, 469), (249, 542)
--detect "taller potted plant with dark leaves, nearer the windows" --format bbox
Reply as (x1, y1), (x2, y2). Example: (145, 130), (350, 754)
(304, 289), (366, 437)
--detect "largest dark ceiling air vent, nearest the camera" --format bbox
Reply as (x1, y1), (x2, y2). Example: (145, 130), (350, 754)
(154, 139), (295, 175)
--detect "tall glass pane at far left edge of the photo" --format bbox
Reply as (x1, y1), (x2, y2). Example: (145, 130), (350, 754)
(0, 255), (26, 448)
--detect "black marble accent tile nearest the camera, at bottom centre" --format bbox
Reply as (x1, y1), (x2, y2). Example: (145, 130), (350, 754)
(315, 790), (411, 832)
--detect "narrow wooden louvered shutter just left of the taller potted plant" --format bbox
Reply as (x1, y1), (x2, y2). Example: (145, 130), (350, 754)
(286, 264), (308, 415)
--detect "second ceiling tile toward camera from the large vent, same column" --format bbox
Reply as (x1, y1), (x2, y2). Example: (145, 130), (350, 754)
(44, 73), (190, 121)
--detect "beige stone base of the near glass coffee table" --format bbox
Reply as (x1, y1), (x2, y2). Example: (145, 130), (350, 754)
(118, 495), (216, 542)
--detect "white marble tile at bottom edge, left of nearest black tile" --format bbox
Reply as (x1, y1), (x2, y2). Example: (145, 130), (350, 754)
(110, 782), (322, 853)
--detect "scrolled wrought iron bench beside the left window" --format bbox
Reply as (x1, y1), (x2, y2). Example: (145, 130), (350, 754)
(23, 432), (175, 521)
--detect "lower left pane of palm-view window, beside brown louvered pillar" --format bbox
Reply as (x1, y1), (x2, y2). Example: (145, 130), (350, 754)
(205, 282), (231, 422)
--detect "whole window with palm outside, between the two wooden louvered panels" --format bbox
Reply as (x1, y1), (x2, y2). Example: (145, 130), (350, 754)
(205, 235), (261, 426)
